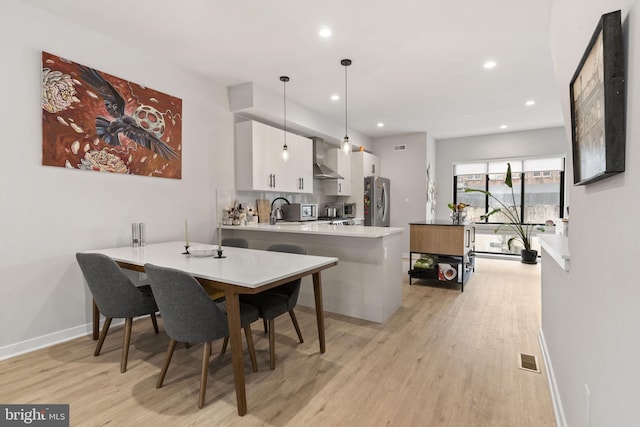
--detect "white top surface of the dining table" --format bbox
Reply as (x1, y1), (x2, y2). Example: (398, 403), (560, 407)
(84, 242), (338, 288)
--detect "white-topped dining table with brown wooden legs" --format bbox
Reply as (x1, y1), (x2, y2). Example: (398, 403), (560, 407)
(84, 241), (338, 415)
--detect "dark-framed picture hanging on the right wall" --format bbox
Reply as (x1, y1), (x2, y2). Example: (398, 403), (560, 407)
(570, 10), (626, 185)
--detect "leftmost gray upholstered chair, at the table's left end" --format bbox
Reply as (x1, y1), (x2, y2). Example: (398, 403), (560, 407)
(76, 253), (158, 372)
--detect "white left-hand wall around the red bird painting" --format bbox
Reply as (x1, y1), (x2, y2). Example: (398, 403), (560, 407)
(0, 0), (234, 358)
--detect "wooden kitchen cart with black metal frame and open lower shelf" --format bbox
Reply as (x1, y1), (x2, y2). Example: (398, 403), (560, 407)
(409, 220), (475, 292)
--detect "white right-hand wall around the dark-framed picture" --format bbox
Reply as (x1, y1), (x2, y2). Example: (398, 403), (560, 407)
(542, 0), (640, 426)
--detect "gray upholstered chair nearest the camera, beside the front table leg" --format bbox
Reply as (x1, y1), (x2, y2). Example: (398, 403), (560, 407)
(144, 264), (259, 408)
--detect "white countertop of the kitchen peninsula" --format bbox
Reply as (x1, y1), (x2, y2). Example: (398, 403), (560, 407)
(222, 222), (404, 238)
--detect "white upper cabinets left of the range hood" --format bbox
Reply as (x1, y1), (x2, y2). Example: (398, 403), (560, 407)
(235, 121), (313, 193)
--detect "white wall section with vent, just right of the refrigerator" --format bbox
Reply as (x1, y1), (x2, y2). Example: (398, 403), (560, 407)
(373, 132), (427, 253)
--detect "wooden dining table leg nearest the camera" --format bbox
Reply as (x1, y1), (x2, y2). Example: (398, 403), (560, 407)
(225, 289), (247, 415)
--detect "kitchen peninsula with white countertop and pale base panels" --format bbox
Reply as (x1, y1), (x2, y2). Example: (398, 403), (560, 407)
(222, 222), (403, 323)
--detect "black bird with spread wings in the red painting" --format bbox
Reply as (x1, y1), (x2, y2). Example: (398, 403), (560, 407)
(79, 65), (178, 160)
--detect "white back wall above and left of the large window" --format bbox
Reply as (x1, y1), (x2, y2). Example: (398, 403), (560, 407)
(435, 127), (573, 219)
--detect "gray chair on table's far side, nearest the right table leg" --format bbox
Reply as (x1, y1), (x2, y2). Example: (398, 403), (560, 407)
(240, 243), (307, 370)
